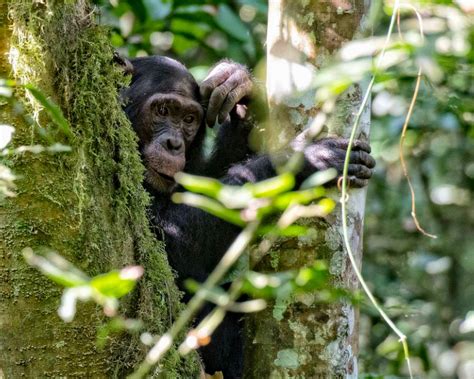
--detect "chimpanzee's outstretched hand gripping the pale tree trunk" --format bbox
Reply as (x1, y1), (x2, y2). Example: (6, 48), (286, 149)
(300, 138), (375, 187)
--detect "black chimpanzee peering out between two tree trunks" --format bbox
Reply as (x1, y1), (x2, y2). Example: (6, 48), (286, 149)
(122, 56), (375, 379)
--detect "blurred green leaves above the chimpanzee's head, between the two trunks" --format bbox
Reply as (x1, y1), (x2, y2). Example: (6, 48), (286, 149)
(97, 0), (267, 72)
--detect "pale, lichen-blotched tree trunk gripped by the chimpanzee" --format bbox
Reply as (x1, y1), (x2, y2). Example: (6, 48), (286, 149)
(245, 0), (370, 378)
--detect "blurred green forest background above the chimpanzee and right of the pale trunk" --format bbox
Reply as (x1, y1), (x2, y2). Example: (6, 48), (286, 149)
(96, 0), (474, 379)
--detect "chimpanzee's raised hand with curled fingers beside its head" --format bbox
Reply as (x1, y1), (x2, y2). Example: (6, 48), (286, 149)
(200, 60), (253, 127)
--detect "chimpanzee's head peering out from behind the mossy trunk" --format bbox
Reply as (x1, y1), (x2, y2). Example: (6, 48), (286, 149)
(122, 56), (205, 192)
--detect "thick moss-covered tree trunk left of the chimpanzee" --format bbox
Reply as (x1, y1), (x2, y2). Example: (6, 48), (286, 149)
(0, 0), (197, 378)
